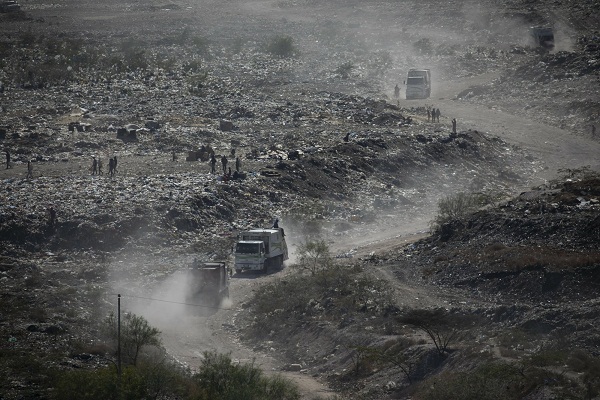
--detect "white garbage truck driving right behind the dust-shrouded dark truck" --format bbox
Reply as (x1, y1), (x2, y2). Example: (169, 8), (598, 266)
(234, 228), (288, 274)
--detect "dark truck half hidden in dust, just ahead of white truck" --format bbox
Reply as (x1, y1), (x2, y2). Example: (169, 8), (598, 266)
(187, 260), (229, 307)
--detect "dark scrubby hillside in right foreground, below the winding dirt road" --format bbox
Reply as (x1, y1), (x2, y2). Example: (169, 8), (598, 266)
(243, 170), (600, 399)
